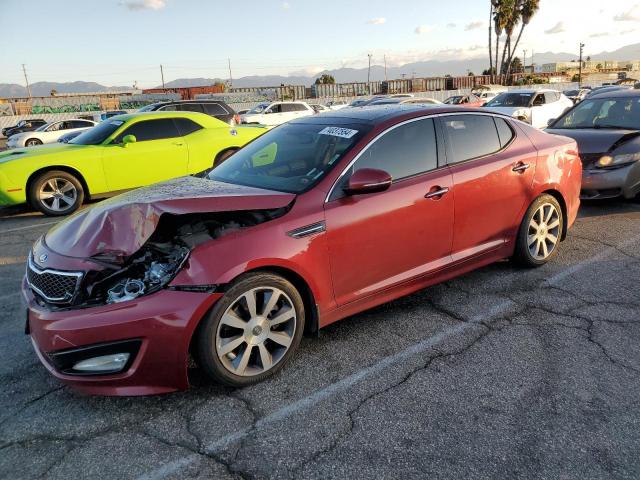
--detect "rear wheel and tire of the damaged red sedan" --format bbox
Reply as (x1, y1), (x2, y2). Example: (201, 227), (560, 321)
(515, 194), (564, 267)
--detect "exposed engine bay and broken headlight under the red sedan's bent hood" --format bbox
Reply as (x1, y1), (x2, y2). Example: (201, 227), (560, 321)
(34, 205), (290, 310)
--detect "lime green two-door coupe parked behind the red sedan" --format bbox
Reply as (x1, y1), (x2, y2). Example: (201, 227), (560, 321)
(0, 112), (266, 216)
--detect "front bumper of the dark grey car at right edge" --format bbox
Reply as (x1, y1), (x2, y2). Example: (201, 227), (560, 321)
(580, 162), (640, 200)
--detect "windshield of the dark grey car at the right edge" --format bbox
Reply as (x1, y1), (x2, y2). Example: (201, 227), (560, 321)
(552, 97), (640, 130)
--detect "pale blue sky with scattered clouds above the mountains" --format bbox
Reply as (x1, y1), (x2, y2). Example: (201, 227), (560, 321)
(0, 0), (640, 87)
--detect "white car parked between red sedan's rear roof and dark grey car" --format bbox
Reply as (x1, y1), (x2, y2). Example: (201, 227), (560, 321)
(484, 89), (573, 128)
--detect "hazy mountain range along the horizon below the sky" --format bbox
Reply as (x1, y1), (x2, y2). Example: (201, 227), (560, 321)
(0, 43), (640, 97)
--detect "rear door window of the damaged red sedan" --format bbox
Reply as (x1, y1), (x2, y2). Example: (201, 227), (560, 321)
(443, 115), (500, 163)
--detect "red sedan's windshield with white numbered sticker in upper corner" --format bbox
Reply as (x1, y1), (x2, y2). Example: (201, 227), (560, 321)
(208, 123), (371, 193)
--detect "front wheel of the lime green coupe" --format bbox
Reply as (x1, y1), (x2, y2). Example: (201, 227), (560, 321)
(29, 170), (84, 216)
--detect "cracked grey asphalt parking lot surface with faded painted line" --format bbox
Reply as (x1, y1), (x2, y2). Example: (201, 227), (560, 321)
(0, 202), (640, 479)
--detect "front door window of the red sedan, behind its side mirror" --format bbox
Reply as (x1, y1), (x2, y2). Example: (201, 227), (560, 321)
(344, 118), (438, 182)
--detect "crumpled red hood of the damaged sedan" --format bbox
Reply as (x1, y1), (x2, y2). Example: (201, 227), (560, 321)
(45, 177), (295, 258)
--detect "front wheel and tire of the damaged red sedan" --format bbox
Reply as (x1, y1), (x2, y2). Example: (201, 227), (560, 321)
(195, 272), (305, 387)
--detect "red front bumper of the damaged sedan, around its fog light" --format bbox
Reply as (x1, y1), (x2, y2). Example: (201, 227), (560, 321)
(22, 280), (222, 396)
